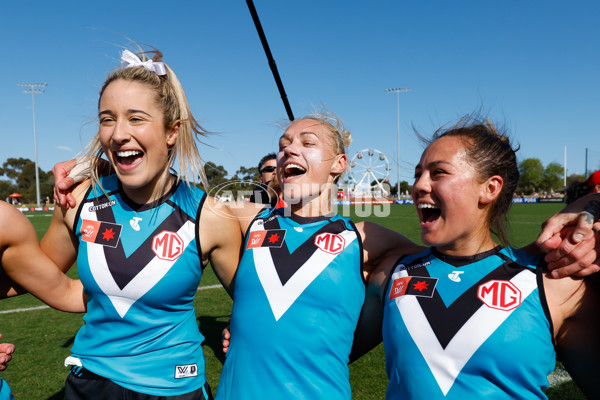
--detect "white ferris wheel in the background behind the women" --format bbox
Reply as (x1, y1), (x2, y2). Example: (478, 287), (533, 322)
(350, 149), (392, 196)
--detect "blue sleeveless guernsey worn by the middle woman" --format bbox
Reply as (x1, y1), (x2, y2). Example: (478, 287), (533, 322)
(215, 209), (365, 400)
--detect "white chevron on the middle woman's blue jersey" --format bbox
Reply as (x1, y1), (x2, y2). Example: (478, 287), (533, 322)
(252, 231), (356, 321)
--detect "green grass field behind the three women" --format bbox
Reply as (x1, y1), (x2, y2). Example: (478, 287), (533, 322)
(0, 204), (584, 400)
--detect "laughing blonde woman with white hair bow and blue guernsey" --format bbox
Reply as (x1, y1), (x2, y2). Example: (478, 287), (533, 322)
(35, 50), (241, 400)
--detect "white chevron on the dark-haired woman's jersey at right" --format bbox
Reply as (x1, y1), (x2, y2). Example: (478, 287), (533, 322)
(392, 271), (537, 396)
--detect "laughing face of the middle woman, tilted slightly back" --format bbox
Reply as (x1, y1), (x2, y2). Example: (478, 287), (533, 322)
(277, 119), (347, 204)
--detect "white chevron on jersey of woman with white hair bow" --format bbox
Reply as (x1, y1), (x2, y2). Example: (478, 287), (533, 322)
(81, 203), (196, 318)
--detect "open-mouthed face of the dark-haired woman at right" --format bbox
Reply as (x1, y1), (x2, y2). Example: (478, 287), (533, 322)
(412, 137), (501, 255)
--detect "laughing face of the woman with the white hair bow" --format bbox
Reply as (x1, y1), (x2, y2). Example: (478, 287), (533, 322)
(98, 79), (179, 203)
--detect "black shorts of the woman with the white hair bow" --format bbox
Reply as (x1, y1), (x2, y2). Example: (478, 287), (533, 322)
(65, 367), (213, 400)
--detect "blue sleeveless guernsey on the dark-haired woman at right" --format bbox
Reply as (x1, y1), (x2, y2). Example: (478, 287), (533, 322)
(383, 247), (555, 400)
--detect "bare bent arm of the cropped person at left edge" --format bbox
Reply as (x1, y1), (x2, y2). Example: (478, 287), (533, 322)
(0, 202), (85, 312)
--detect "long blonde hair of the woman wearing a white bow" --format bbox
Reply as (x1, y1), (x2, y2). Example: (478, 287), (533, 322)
(84, 46), (208, 198)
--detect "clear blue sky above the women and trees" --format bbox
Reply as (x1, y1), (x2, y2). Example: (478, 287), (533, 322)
(0, 0), (600, 183)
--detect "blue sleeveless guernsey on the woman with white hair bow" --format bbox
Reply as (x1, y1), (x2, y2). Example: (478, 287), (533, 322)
(71, 175), (206, 396)
